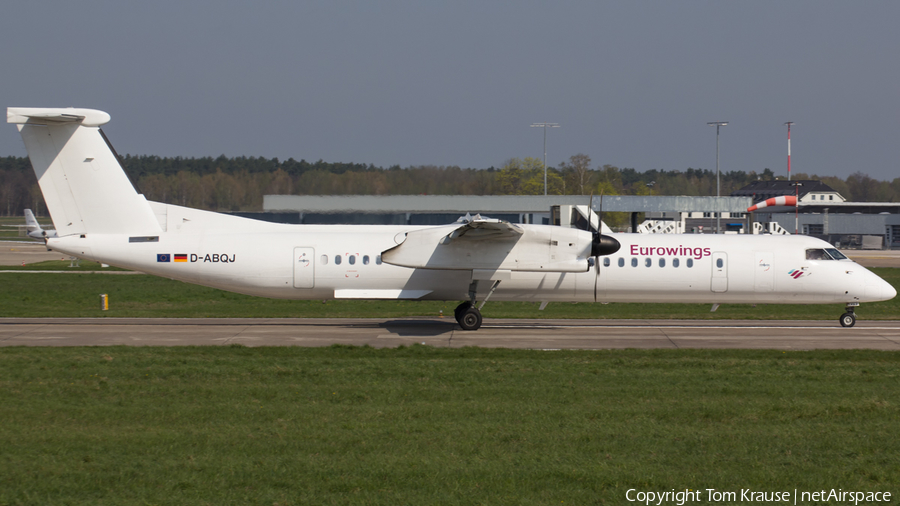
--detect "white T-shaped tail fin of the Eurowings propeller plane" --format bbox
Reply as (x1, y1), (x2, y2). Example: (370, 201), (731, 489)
(6, 107), (162, 237)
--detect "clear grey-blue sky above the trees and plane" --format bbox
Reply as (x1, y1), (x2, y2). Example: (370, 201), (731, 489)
(0, 0), (900, 180)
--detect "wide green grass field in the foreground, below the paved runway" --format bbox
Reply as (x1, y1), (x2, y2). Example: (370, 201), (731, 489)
(0, 346), (900, 505)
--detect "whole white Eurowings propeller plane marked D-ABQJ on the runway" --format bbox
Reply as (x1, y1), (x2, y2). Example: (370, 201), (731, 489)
(7, 107), (897, 330)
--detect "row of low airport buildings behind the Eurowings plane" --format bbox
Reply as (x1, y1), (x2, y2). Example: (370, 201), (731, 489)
(255, 180), (900, 249)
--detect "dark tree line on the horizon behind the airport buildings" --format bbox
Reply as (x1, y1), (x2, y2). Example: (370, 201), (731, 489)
(0, 154), (900, 216)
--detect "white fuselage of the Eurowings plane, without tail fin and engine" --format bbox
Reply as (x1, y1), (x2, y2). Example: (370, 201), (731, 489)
(48, 203), (896, 304)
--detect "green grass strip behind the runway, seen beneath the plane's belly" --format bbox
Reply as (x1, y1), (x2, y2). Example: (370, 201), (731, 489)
(0, 261), (900, 320)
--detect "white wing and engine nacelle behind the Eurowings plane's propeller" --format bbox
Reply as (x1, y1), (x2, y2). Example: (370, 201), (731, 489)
(381, 215), (591, 272)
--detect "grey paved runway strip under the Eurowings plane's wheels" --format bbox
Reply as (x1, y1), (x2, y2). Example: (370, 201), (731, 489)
(0, 318), (900, 350)
